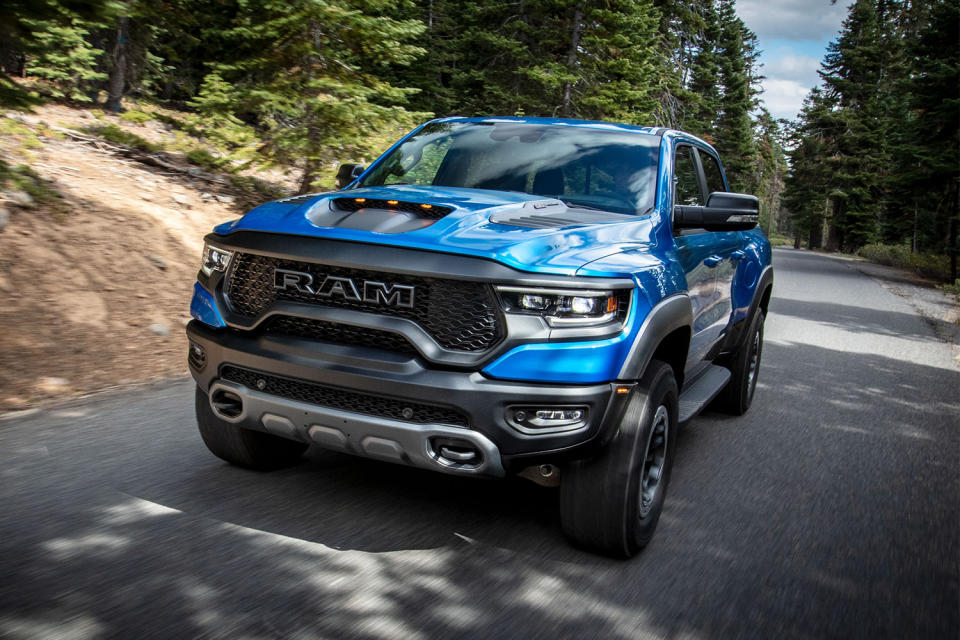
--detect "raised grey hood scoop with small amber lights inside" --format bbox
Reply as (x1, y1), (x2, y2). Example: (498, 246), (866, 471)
(307, 198), (453, 233)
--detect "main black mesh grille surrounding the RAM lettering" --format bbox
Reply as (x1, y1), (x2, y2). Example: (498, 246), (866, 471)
(228, 253), (503, 352)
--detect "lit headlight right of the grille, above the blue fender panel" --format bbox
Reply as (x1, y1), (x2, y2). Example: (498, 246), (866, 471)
(497, 287), (627, 326)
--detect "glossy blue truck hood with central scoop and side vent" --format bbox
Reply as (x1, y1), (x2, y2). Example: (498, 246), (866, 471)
(214, 185), (658, 275)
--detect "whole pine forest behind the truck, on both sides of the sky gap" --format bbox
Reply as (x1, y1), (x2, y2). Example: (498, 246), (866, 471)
(0, 0), (960, 282)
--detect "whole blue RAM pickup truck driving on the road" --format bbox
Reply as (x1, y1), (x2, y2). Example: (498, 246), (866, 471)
(187, 118), (773, 557)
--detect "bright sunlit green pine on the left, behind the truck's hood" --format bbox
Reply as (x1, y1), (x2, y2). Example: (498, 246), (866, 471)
(194, 0), (425, 193)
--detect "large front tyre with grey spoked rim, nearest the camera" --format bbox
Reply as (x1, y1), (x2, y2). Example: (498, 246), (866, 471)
(560, 360), (678, 558)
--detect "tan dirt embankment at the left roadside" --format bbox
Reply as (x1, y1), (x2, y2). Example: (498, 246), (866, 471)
(0, 101), (290, 411)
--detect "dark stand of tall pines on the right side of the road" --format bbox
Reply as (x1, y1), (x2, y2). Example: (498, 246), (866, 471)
(786, 0), (960, 280)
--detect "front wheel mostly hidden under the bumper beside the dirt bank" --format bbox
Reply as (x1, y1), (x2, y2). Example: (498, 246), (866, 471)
(196, 387), (307, 471)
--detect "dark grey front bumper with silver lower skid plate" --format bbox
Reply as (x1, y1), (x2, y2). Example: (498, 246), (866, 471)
(187, 321), (630, 476)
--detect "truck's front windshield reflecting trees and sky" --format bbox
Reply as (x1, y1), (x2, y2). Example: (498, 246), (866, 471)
(361, 122), (660, 214)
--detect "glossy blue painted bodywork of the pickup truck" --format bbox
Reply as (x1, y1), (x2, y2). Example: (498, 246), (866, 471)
(191, 118), (771, 383)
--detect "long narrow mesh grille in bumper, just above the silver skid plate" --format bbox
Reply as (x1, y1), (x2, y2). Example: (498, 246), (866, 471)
(220, 365), (469, 427)
